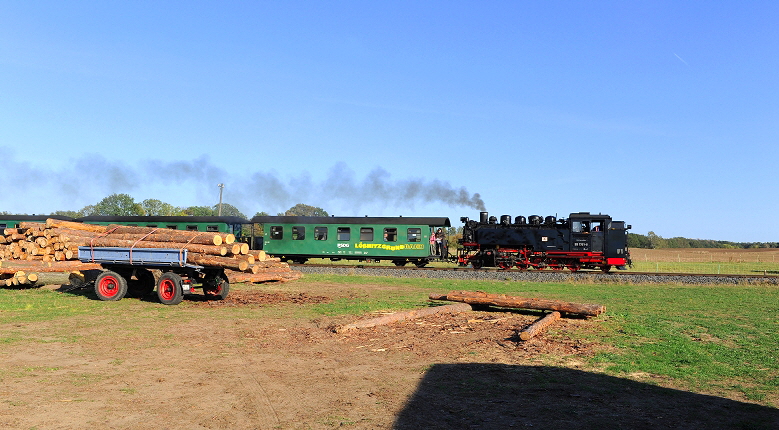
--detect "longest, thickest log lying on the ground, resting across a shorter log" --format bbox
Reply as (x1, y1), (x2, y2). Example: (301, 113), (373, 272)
(430, 291), (606, 316)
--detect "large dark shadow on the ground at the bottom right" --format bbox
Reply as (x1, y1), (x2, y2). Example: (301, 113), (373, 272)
(394, 363), (779, 429)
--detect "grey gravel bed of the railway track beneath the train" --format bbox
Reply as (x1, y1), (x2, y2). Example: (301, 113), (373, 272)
(294, 265), (779, 285)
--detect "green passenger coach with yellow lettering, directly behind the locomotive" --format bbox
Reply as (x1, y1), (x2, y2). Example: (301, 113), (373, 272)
(252, 216), (451, 267)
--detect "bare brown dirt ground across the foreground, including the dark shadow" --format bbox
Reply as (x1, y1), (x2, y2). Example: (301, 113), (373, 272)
(0, 284), (779, 429)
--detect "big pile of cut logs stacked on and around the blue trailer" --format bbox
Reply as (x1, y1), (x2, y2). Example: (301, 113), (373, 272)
(0, 218), (301, 282)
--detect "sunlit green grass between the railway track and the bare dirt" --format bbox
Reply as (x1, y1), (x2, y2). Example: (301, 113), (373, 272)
(0, 275), (779, 407)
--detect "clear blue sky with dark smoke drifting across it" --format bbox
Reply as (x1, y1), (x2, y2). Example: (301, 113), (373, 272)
(0, 1), (779, 242)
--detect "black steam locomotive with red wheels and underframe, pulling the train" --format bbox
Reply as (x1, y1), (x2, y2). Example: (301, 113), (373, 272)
(457, 212), (631, 272)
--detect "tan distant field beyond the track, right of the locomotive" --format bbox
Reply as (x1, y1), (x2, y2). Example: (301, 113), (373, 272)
(630, 248), (779, 275)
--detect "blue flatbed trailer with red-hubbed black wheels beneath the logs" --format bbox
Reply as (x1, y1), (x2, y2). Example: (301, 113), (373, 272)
(78, 246), (230, 305)
